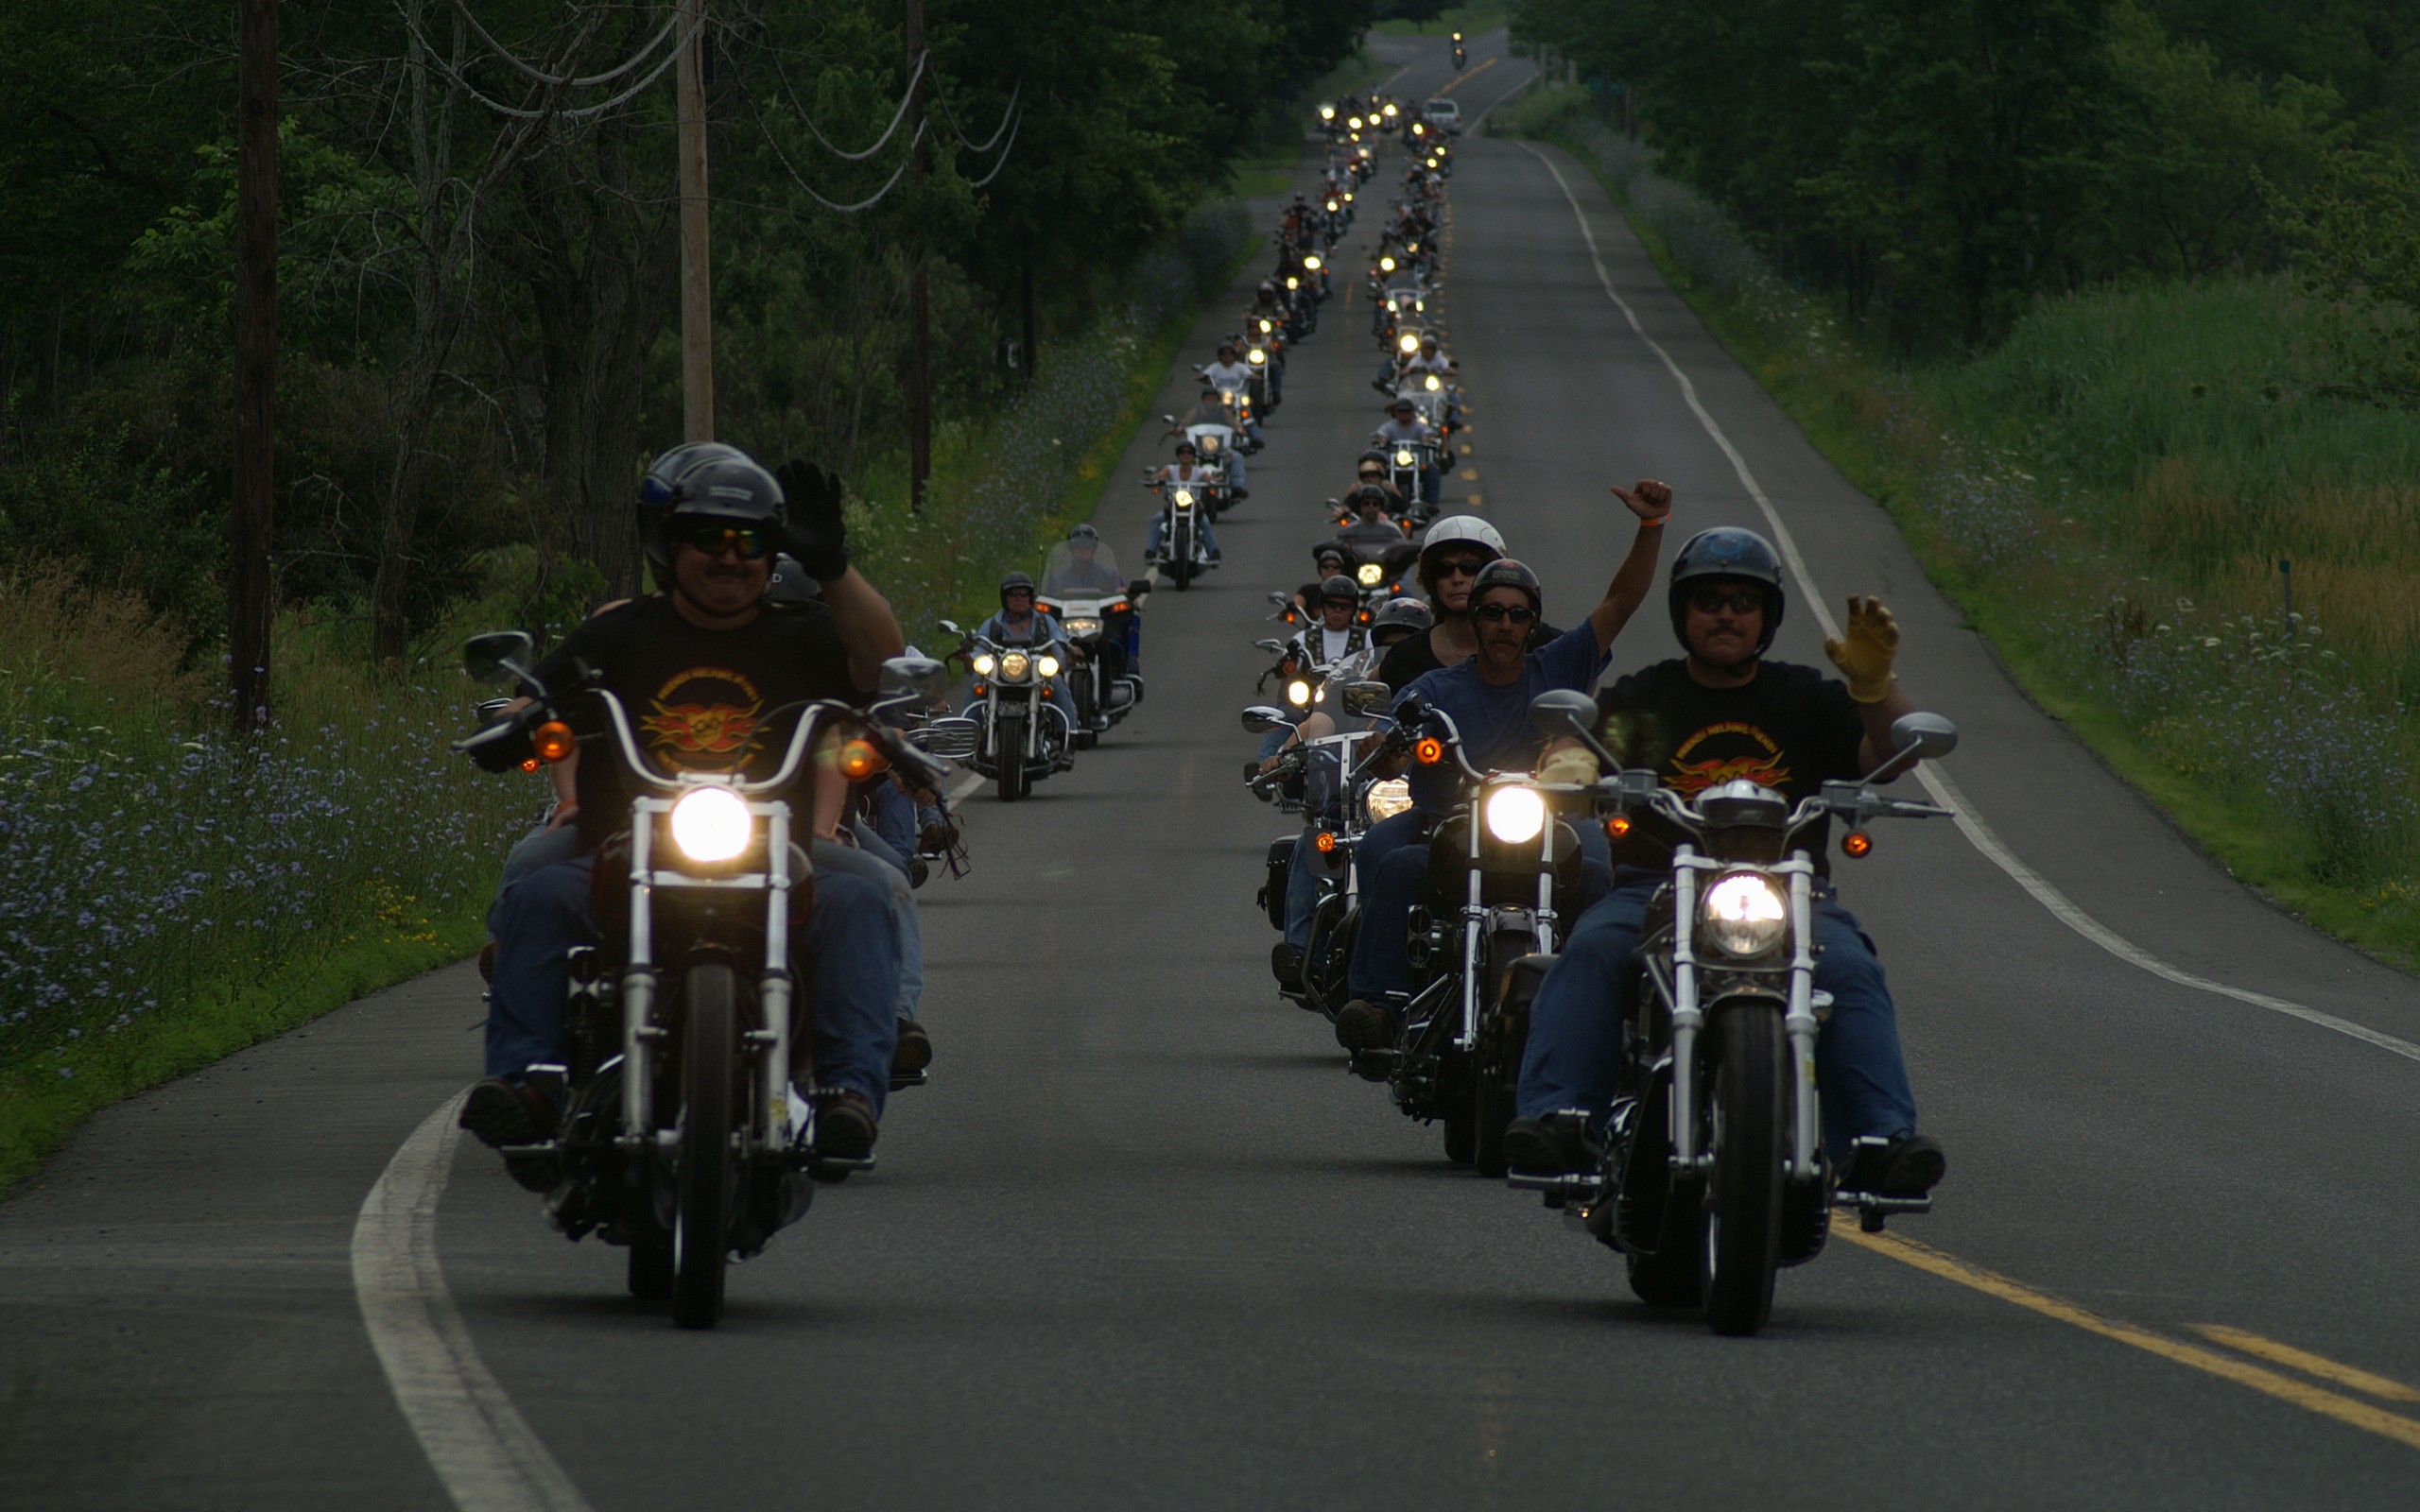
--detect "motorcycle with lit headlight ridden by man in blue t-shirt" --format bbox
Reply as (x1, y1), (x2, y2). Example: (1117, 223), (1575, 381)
(1356, 682), (1595, 1176)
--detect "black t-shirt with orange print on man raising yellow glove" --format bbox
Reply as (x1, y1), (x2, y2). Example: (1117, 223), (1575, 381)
(1598, 658), (1866, 871)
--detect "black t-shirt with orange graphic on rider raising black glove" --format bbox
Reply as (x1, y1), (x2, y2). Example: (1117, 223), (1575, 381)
(537, 593), (866, 850)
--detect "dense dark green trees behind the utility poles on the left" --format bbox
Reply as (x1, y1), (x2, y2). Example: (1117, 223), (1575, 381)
(0, 0), (1373, 661)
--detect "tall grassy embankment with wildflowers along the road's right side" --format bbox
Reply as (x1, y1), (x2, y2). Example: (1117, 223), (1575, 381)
(1500, 90), (2420, 965)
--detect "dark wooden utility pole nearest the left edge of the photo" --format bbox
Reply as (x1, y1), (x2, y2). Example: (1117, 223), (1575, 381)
(228, 0), (278, 735)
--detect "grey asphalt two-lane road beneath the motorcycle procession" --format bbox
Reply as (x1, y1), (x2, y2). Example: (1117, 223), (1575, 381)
(14, 36), (2420, 1512)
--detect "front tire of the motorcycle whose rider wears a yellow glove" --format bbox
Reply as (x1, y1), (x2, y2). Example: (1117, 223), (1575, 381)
(1703, 1004), (1790, 1335)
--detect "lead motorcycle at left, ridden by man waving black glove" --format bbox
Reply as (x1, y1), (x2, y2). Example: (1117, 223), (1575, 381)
(453, 631), (946, 1328)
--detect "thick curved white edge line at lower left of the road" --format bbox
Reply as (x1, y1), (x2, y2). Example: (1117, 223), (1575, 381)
(354, 1096), (591, 1512)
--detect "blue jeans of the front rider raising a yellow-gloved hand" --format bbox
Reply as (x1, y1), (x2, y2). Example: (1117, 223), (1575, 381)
(1515, 866), (1917, 1161)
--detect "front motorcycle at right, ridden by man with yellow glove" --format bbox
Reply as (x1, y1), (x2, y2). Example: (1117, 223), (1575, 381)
(1512, 692), (1958, 1333)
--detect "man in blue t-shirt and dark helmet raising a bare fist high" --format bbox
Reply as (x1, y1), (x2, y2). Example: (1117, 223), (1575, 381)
(1336, 479), (1672, 1050)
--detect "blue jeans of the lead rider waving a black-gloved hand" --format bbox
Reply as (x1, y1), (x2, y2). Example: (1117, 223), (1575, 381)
(487, 856), (898, 1113)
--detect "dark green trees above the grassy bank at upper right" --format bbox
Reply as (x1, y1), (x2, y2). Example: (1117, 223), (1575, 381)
(1515, 0), (2420, 351)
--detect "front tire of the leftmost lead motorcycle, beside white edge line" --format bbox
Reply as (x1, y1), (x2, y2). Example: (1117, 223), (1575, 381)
(673, 965), (738, 1328)
